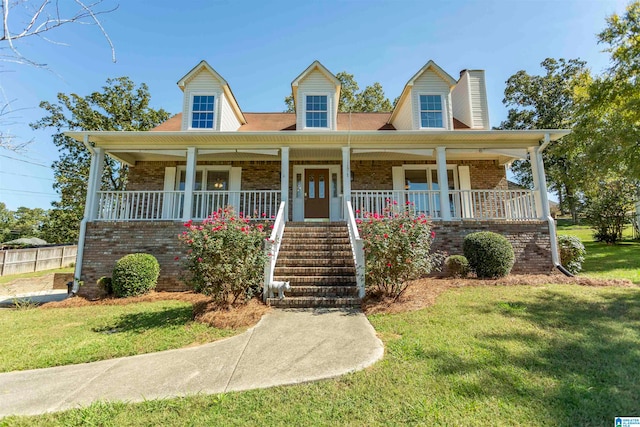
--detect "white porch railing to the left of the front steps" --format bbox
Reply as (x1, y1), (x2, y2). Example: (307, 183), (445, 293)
(94, 190), (280, 221)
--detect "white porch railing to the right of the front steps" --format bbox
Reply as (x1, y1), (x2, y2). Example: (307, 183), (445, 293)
(351, 190), (539, 220)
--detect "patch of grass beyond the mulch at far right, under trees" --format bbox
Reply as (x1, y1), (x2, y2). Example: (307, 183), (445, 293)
(558, 220), (640, 284)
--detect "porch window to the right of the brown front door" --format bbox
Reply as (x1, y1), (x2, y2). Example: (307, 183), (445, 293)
(404, 168), (457, 218)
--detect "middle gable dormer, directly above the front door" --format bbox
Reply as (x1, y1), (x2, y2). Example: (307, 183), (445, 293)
(291, 61), (341, 131)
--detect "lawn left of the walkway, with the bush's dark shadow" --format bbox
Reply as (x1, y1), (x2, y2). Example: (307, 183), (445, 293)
(0, 301), (237, 372)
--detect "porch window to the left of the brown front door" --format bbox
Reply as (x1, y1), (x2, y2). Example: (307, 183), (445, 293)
(176, 169), (232, 218)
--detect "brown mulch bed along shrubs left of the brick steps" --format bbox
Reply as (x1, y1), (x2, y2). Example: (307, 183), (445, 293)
(41, 292), (270, 329)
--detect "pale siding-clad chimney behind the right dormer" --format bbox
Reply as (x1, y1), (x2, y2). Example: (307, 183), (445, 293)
(451, 70), (491, 130)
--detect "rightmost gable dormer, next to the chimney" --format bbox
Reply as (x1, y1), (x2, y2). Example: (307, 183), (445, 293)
(389, 61), (457, 130)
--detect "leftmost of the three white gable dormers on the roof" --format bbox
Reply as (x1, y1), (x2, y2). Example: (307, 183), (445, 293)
(178, 60), (247, 131)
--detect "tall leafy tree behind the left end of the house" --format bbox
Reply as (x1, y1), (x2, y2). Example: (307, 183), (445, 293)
(31, 77), (170, 242)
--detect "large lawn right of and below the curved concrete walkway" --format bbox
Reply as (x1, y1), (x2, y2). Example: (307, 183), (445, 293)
(5, 285), (640, 426)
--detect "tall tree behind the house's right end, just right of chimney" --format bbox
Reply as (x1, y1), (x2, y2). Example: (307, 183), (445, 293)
(500, 58), (591, 220)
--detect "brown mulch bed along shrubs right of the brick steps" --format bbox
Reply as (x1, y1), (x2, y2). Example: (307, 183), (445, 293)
(362, 274), (637, 314)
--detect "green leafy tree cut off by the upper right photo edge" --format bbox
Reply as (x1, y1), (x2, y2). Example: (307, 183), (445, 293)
(575, 1), (640, 185)
